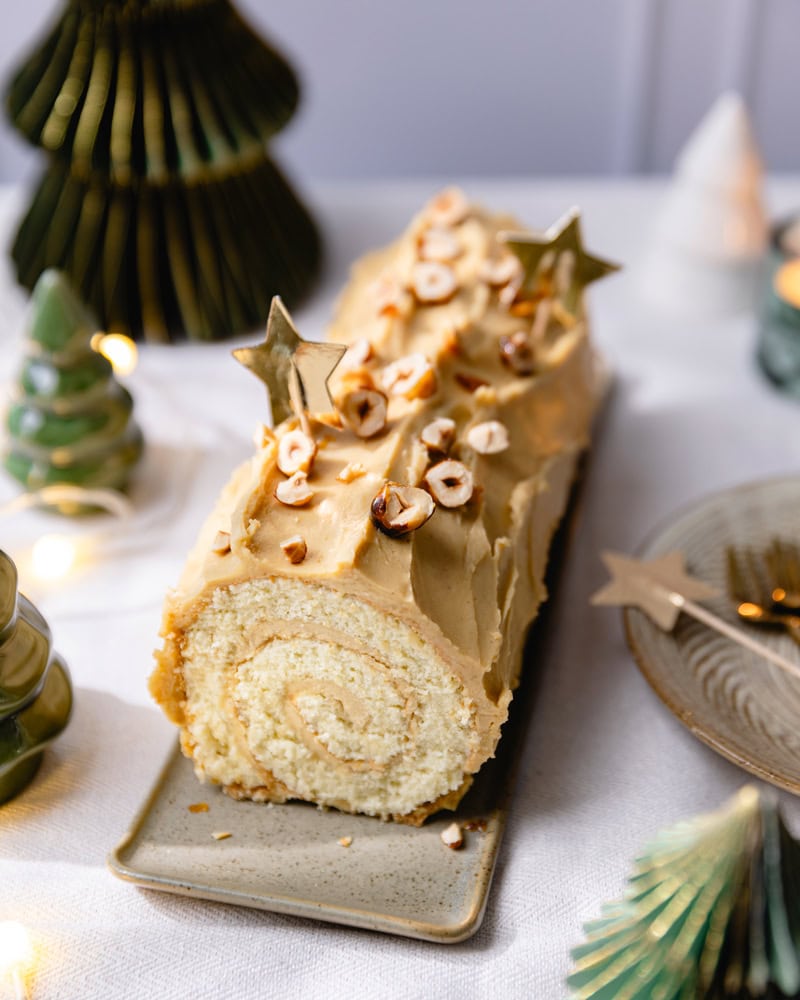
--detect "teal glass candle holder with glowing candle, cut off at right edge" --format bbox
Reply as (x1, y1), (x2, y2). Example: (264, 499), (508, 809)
(757, 216), (800, 398)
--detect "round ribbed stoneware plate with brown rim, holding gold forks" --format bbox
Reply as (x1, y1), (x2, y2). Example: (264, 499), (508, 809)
(624, 477), (800, 794)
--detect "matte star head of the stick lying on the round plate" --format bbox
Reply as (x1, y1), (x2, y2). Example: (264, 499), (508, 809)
(591, 552), (719, 631)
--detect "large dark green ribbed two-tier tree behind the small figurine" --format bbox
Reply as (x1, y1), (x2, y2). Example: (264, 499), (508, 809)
(7, 0), (320, 341)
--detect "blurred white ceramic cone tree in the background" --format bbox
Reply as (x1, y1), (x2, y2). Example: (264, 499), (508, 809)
(640, 92), (767, 316)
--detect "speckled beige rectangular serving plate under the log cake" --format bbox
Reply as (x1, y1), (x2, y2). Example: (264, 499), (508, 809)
(108, 374), (611, 944)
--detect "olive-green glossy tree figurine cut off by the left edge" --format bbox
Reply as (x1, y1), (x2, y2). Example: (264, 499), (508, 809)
(0, 552), (72, 803)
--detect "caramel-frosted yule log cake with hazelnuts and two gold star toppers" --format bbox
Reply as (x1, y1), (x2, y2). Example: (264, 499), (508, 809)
(151, 189), (612, 824)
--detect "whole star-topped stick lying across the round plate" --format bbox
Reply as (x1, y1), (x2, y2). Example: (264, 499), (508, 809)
(591, 552), (800, 677)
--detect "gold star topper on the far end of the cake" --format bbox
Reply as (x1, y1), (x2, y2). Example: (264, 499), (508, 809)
(498, 208), (619, 314)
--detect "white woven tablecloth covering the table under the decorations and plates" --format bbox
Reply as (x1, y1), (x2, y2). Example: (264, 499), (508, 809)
(0, 179), (800, 1000)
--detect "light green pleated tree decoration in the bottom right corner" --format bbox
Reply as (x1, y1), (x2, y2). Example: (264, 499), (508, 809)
(568, 786), (800, 1000)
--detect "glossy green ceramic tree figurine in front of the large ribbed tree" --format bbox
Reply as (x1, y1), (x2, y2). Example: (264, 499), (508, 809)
(3, 270), (142, 500)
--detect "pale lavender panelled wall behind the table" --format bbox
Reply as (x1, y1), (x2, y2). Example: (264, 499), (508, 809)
(0, 0), (800, 180)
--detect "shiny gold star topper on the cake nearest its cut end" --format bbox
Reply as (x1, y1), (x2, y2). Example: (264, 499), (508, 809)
(233, 295), (347, 425)
